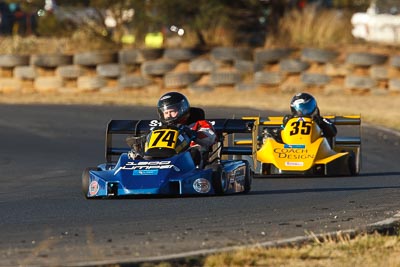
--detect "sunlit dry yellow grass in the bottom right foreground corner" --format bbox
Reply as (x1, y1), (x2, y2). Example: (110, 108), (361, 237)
(204, 234), (400, 267)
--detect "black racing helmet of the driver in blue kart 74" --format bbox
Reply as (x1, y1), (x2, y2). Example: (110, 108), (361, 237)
(157, 92), (190, 124)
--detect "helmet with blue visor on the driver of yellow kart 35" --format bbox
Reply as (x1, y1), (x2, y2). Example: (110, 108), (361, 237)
(290, 93), (318, 117)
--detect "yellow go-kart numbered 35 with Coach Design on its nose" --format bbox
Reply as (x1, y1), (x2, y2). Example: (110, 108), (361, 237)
(235, 116), (361, 176)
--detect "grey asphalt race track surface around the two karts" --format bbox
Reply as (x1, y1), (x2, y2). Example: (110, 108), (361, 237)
(0, 105), (400, 266)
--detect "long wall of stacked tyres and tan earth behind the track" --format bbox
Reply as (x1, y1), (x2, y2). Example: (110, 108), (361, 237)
(0, 47), (400, 95)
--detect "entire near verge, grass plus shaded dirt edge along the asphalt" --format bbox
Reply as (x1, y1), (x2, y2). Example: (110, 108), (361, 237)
(135, 222), (400, 267)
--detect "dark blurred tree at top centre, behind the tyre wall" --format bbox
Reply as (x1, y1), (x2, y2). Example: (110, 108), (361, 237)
(151, 0), (266, 46)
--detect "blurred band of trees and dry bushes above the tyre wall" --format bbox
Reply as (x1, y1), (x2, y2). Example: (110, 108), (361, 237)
(0, 0), (390, 54)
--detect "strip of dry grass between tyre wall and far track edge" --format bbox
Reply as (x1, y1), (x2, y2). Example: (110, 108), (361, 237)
(0, 88), (400, 130)
